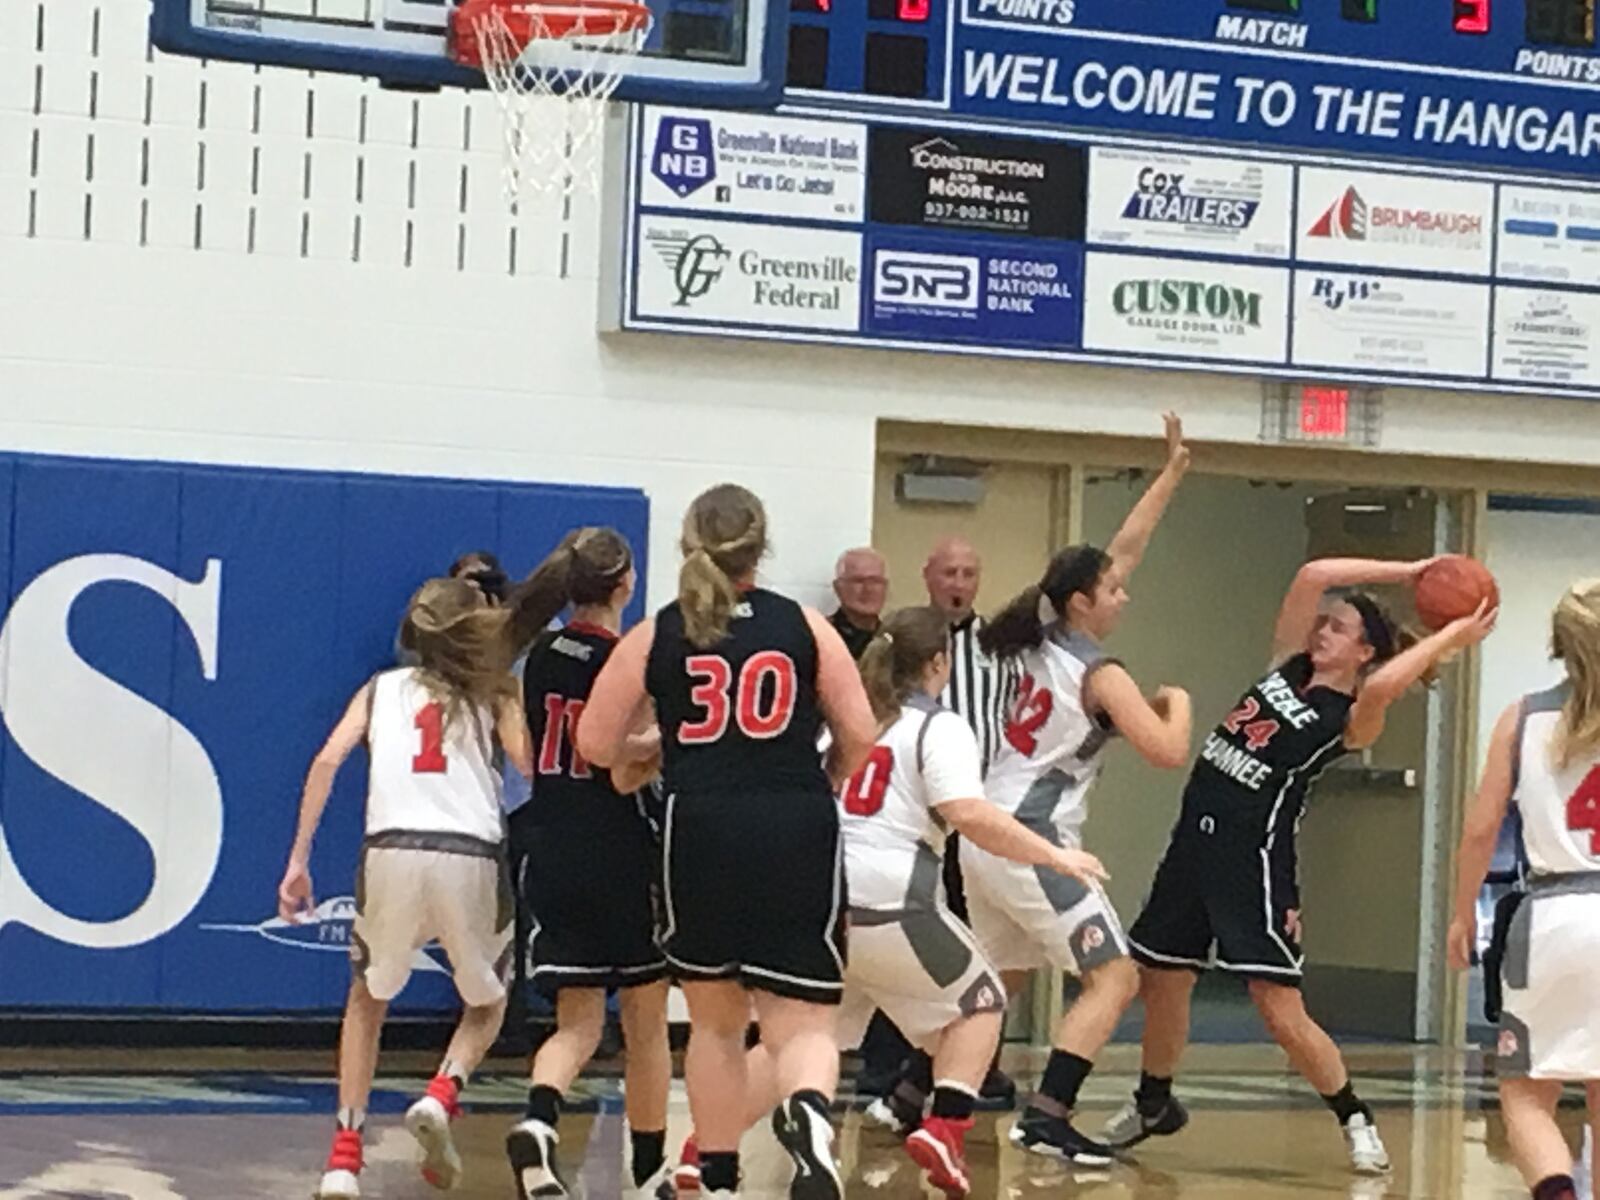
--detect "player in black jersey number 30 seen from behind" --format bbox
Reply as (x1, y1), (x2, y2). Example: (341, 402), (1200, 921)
(578, 483), (877, 1200)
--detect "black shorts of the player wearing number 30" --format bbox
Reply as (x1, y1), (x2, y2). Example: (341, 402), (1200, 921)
(662, 789), (845, 1005)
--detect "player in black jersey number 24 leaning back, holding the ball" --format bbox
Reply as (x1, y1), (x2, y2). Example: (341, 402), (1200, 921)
(1106, 558), (1496, 1173)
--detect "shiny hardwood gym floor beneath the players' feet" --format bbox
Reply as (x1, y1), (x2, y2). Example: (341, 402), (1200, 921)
(0, 1046), (1582, 1200)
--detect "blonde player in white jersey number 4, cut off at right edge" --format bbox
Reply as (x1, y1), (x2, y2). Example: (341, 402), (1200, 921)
(1450, 579), (1600, 1200)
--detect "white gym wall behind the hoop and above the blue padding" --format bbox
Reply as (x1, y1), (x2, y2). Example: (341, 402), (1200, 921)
(0, 0), (1600, 611)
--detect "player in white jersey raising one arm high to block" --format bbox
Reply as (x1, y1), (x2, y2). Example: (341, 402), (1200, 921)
(962, 414), (1190, 1165)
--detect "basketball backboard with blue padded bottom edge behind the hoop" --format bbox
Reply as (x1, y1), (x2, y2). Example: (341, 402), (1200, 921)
(150, 0), (789, 109)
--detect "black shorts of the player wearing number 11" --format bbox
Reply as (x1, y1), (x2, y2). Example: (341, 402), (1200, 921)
(512, 809), (667, 997)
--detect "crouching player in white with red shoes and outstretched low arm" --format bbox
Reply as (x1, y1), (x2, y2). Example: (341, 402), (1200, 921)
(840, 608), (1102, 1197)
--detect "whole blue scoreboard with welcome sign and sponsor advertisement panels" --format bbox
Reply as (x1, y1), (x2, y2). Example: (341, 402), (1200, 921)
(606, 0), (1600, 400)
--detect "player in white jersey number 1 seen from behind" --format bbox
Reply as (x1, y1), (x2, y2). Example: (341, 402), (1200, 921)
(278, 579), (533, 1200)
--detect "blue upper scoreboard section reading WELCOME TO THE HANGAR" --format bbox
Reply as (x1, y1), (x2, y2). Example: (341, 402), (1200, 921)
(789, 0), (1600, 176)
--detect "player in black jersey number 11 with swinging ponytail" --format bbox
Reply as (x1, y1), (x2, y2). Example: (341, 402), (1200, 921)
(506, 528), (672, 1200)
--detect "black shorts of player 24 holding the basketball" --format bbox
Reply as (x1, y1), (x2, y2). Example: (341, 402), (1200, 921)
(1128, 813), (1306, 987)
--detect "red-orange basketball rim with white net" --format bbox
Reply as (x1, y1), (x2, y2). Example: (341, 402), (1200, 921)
(450, 0), (651, 203)
